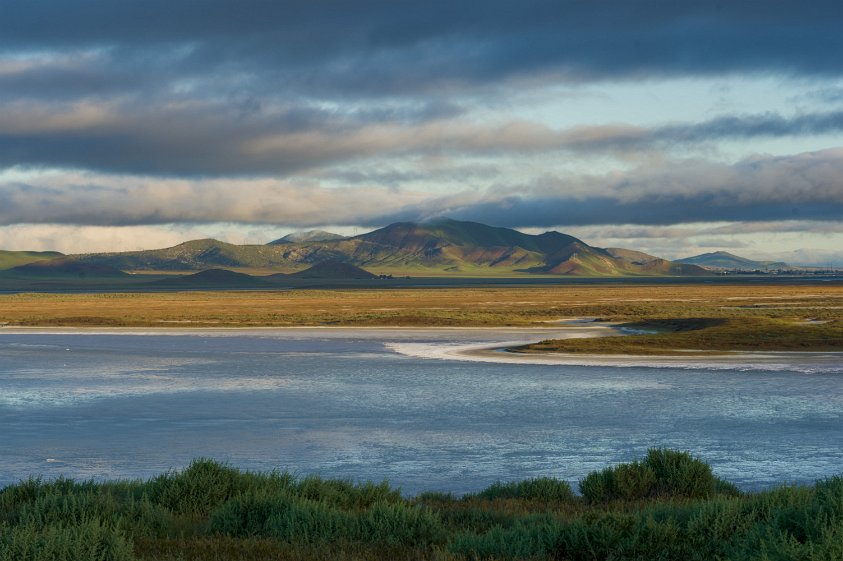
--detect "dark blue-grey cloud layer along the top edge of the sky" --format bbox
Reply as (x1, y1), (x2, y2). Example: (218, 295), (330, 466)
(0, 0), (843, 97)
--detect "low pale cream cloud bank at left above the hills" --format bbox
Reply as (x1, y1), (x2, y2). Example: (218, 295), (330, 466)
(0, 174), (429, 227)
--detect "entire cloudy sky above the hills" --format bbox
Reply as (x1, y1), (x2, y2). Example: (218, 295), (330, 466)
(0, 0), (843, 266)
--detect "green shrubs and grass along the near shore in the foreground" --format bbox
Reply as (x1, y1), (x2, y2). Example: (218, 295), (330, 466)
(0, 449), (843, 561)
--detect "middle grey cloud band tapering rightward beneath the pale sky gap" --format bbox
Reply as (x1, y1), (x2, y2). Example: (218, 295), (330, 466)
(0, 96), (843, 175)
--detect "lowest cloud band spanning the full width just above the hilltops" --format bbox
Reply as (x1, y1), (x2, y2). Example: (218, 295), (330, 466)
(0, 148), (843, 227)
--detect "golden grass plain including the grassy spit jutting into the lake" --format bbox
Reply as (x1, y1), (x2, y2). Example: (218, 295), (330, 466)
(0, 283), (843, 354)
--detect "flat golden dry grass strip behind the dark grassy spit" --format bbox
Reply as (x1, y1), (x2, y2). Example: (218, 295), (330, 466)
(0, 284), (843, 327)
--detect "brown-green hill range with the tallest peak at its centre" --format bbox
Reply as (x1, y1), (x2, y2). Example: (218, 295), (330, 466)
(67, 219), (708, 276)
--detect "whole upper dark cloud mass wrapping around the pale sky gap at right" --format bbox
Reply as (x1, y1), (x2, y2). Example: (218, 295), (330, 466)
(0, 0), (843, 177)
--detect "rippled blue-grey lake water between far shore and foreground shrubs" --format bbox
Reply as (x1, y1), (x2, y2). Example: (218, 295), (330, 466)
(0, 329), (843, 494)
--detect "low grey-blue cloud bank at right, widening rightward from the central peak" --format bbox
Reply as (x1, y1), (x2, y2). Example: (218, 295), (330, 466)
(374, 149), (843, 227)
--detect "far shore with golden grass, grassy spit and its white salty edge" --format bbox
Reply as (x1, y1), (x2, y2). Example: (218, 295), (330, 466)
(0, 284), (843, 358)
